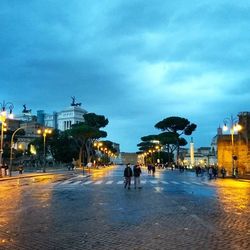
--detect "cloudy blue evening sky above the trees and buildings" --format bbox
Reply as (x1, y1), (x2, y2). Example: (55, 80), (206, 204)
(0, 0), (250, 152)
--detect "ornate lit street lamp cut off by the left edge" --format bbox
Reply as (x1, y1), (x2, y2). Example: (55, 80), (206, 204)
(0, 101), (14, 174)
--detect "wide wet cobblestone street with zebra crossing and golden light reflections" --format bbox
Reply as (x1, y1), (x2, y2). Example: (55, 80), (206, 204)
(0, 166), (250, 250)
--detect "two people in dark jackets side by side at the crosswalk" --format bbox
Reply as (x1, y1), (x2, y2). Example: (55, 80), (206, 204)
(124, 164), (142, 189)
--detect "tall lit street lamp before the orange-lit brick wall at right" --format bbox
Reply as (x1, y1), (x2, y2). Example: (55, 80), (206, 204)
(223, 115), (242, 176)
